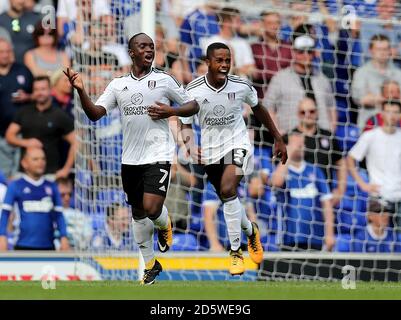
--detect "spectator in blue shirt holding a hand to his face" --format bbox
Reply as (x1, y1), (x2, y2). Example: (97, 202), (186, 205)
(271, 132), (335, 251)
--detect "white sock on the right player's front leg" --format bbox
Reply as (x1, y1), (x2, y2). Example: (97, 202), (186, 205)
(223, 198), (242, 251)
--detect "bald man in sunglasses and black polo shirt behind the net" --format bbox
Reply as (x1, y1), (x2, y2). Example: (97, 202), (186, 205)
(285, 98), (347, 205)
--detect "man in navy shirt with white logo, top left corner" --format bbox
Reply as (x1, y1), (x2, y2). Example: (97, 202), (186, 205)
(0, 0), (41, 63)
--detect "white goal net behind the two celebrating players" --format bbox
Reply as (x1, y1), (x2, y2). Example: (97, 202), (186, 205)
(67, 0), (401, 280)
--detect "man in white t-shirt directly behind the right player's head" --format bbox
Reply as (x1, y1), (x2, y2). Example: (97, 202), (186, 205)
(200, 8), (255, 77)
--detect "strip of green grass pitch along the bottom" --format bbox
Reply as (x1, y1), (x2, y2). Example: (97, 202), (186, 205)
(0, 281), (401, 300)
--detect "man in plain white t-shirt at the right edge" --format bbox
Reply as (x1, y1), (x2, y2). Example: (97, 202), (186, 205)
(347, 100), (401, 229)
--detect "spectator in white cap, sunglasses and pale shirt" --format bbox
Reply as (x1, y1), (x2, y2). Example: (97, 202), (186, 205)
(263, 25), (337, 134)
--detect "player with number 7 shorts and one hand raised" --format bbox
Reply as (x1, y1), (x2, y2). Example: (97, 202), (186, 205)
(65, 33), (199, 285)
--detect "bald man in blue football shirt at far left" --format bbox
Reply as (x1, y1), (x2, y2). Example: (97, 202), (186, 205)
(0, 147), (69, 250)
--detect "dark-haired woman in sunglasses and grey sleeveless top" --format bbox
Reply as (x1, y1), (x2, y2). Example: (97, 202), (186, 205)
(24, 22), (70, 77)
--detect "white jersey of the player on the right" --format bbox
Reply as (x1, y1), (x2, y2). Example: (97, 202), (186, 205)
(180, 75), (258, 165)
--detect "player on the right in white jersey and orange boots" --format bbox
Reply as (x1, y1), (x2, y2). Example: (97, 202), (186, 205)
(152, 42), (287, 275)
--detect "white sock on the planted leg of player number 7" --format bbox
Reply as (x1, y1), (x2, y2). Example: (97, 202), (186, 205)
(133, 218), (155, 269)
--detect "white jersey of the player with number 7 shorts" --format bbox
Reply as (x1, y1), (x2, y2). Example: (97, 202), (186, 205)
(95, 68), (193, 165)
